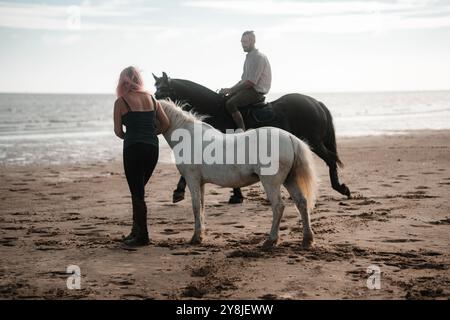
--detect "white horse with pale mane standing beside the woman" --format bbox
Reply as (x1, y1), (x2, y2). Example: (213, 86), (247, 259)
(160, 100), (317, 248)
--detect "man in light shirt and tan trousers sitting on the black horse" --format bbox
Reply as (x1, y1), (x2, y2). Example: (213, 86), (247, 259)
(219, 31), (272, 131)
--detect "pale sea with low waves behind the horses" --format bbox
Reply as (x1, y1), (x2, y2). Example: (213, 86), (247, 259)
(0, 91), (450, 165)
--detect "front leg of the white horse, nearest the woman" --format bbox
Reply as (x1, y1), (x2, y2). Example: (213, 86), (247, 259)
(187, 181), (205, 244)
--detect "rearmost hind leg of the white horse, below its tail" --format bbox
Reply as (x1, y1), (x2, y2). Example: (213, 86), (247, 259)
(284, 177), (314, 248)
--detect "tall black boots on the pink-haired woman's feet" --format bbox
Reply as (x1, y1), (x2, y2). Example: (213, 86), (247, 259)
(123, 196), (150, 247)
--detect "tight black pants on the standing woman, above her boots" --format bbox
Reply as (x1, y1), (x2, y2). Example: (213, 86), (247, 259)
(123, 143), (159, 200)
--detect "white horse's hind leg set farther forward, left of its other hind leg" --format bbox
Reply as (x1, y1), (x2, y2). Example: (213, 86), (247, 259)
(261, 180), (284, 249)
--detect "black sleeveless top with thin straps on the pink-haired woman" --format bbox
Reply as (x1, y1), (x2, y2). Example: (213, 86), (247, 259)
(122, 97), (159, 149)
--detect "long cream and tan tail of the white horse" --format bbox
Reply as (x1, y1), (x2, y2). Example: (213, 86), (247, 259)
(289, 134), (317, 211)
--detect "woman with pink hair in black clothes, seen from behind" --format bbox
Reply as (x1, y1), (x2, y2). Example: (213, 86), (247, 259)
(114, 67), (170, 246)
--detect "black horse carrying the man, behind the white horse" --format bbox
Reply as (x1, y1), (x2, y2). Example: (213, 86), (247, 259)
(153, 72), (350, 203)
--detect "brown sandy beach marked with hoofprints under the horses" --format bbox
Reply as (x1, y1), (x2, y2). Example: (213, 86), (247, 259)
(0, 131), (450, 299)
